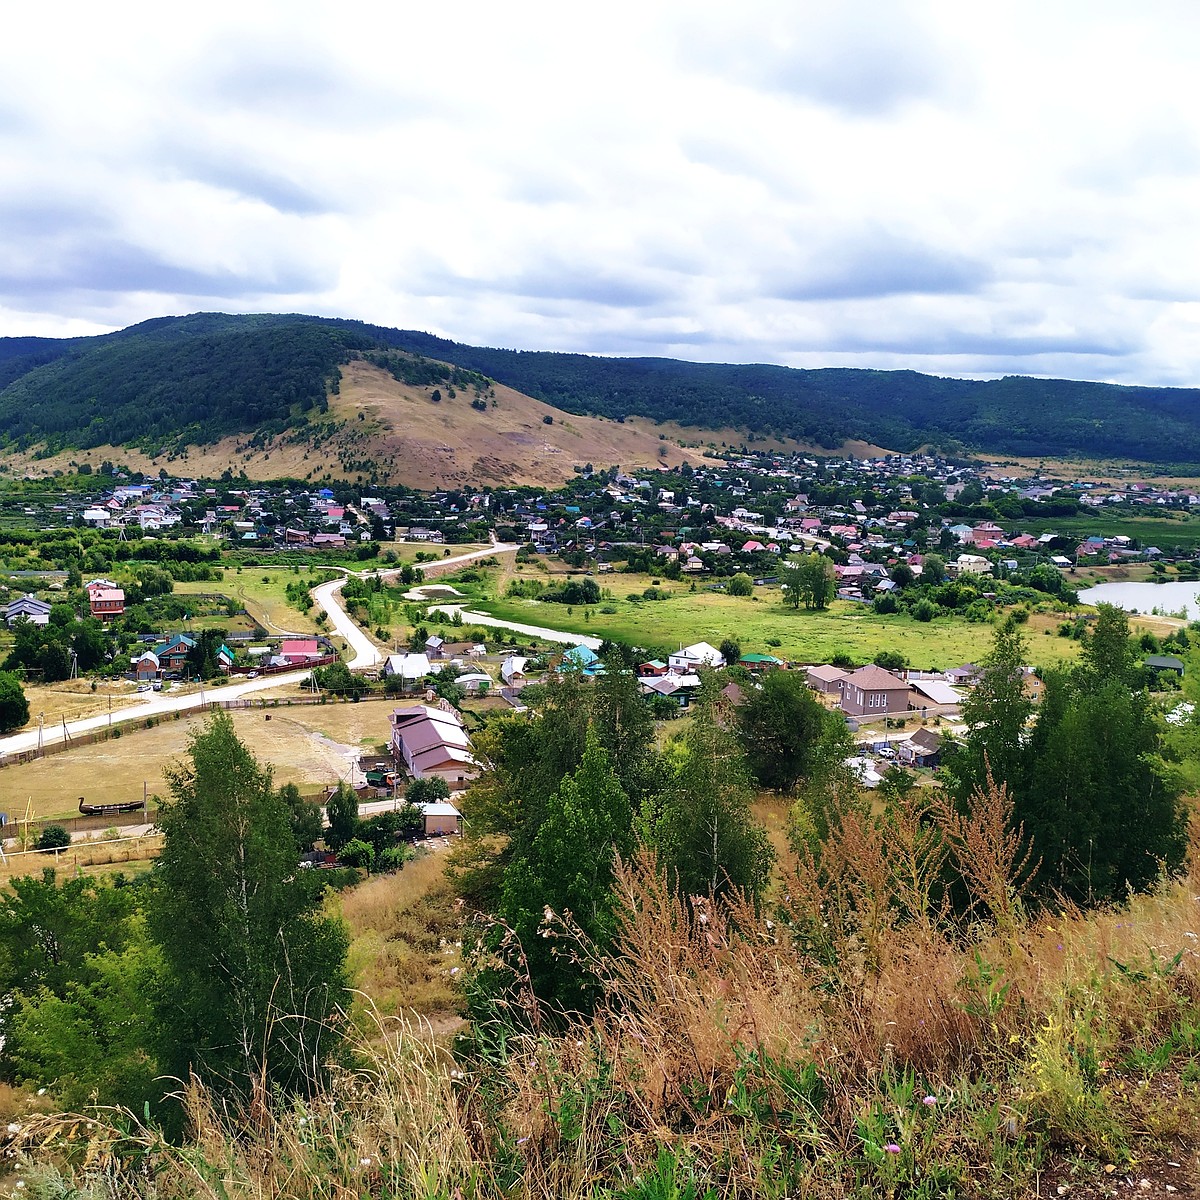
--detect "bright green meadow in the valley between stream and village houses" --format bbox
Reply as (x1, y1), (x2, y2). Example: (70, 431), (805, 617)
(460, 575), (1078, 670)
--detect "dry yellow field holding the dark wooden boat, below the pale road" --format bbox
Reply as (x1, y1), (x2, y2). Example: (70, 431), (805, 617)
(0, 702), (391, 820)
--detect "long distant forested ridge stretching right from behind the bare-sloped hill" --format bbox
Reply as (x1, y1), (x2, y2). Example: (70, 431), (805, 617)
(372, 332), (1200, 462)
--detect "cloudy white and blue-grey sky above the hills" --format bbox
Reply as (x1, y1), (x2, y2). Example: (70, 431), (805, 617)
(0, 0), (1200, 386)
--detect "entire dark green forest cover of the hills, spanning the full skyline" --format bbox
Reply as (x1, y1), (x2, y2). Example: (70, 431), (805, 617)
(0, 313), (1200, 463)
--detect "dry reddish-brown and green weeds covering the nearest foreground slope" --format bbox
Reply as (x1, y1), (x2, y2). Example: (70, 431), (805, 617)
(10, 791), (1200, 1200)
